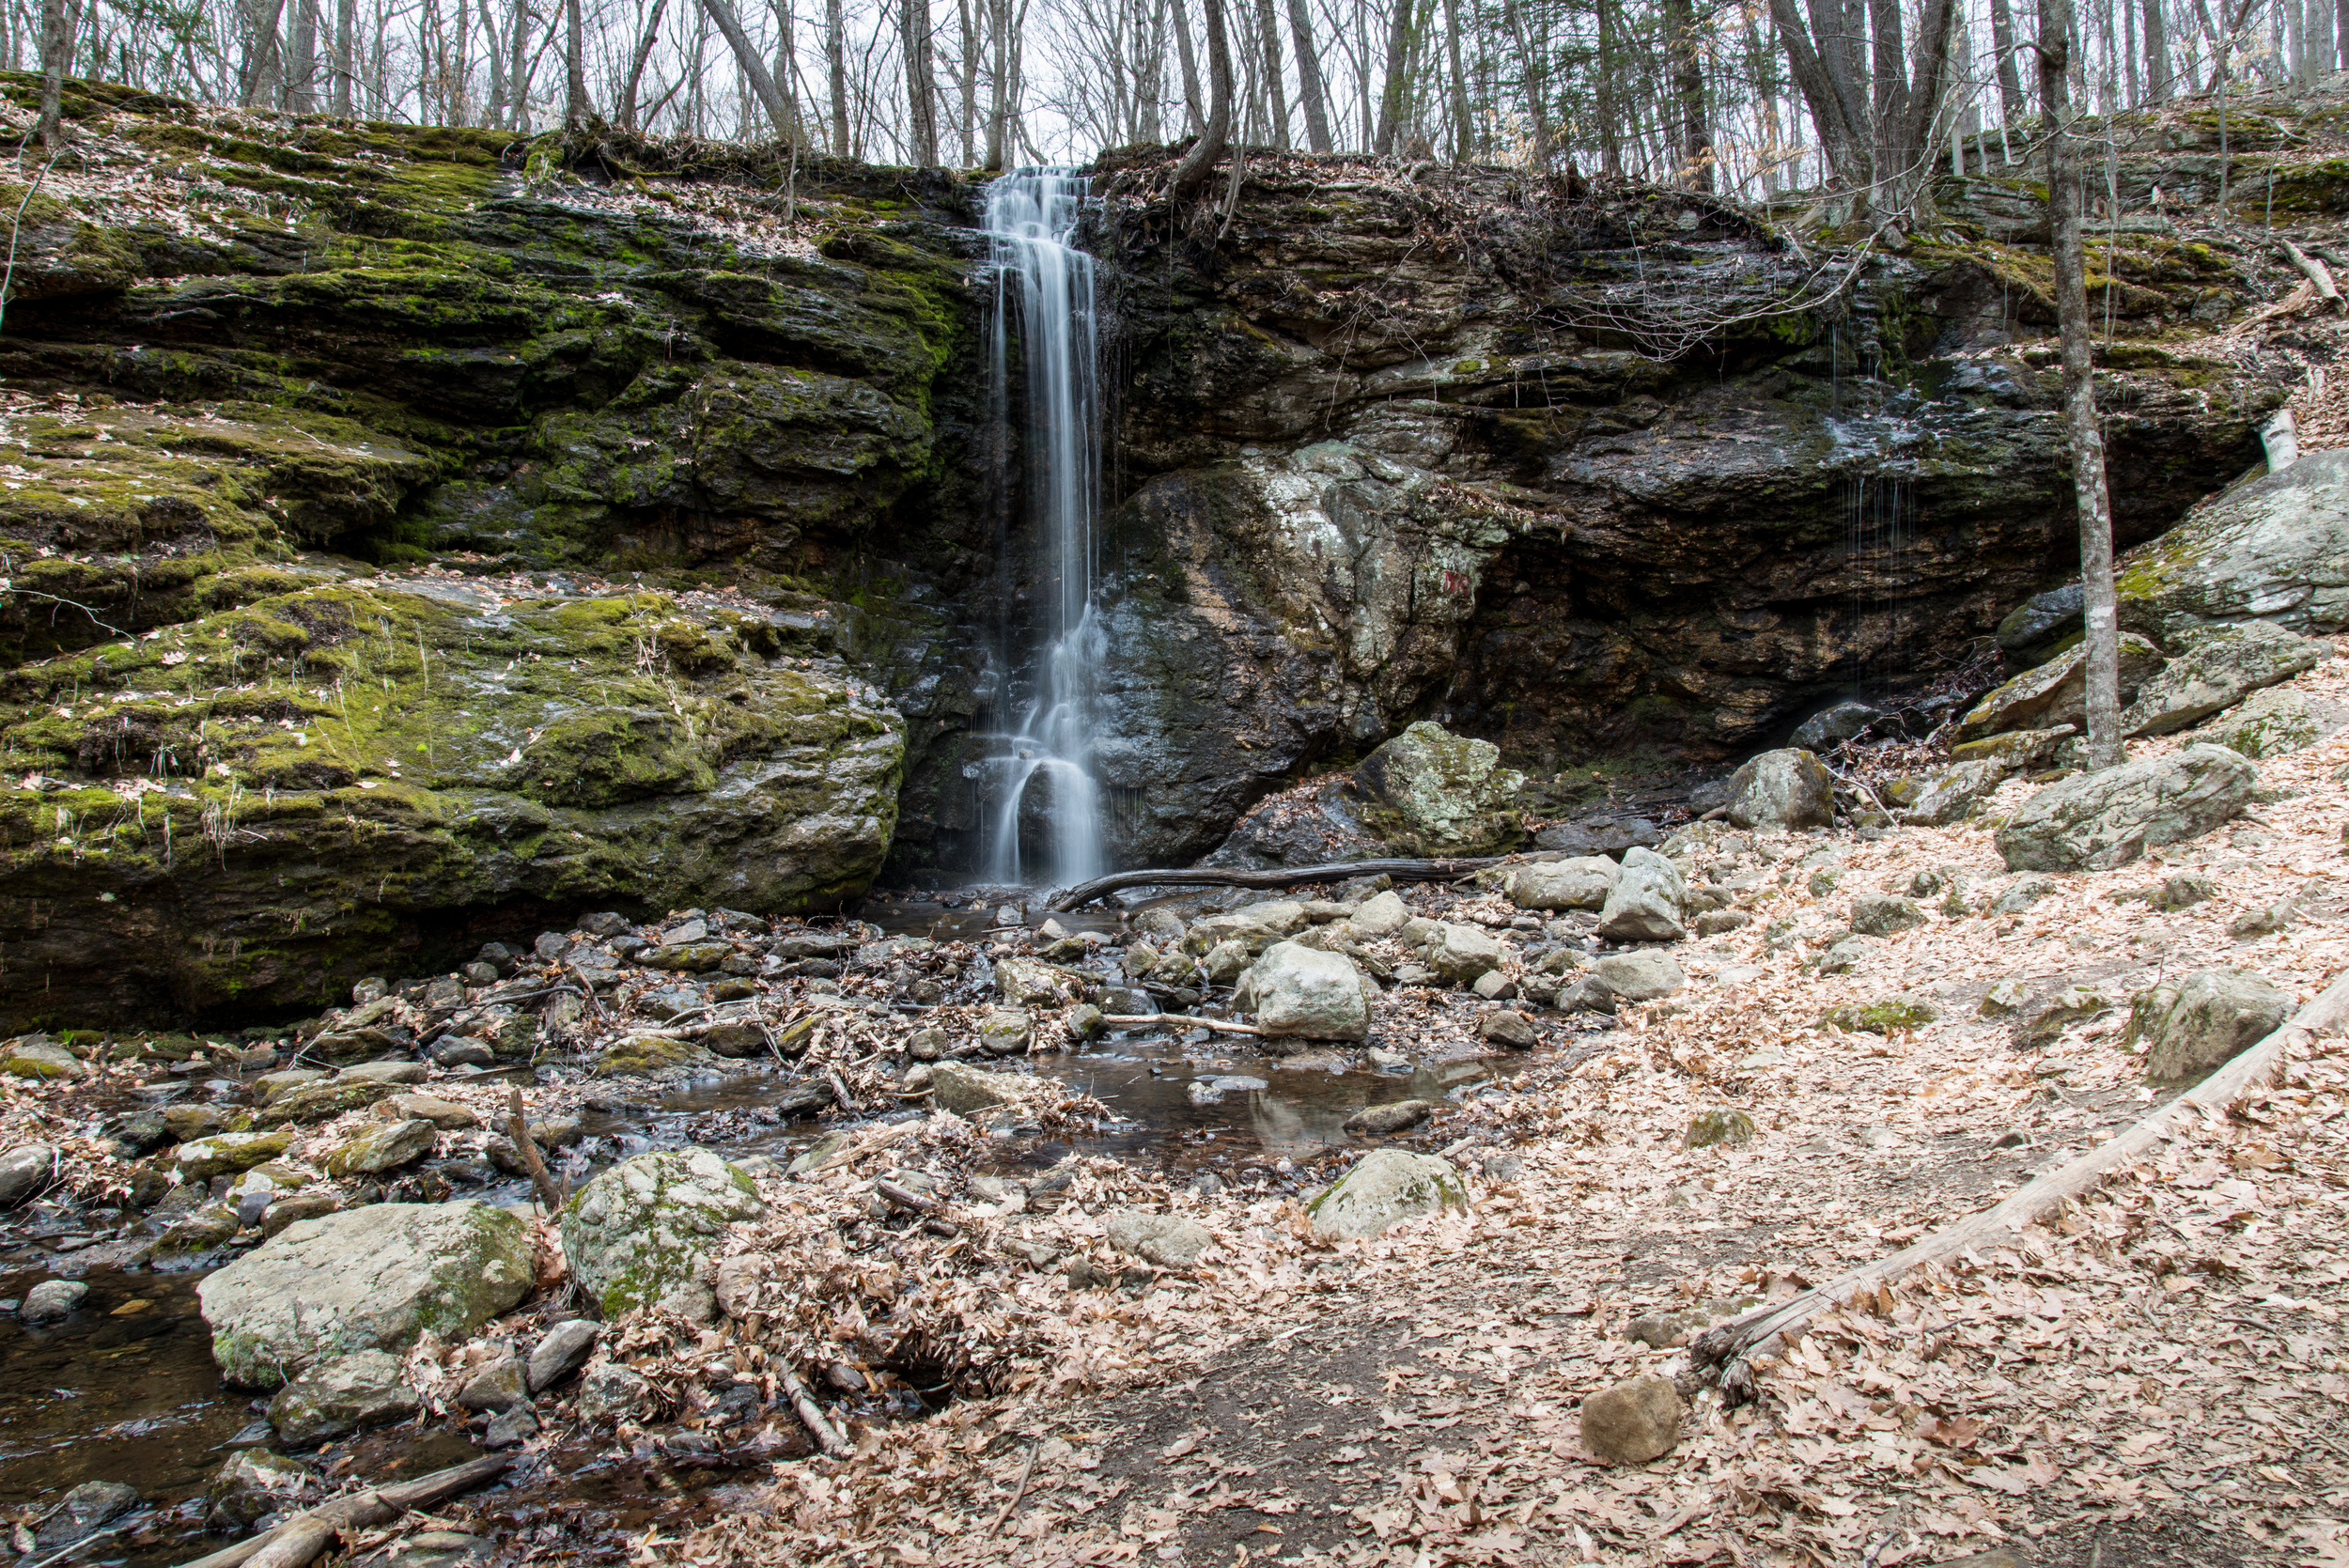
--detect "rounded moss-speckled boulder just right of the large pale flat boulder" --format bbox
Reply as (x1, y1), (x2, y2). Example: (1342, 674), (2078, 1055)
(564, 1148), (766, 1319)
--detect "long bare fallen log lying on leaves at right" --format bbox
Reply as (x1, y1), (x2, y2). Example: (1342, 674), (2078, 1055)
(1689, 974), (2349, 1404)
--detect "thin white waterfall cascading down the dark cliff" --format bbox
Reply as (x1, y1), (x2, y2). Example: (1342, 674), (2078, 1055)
(987, 169), (1109, 887)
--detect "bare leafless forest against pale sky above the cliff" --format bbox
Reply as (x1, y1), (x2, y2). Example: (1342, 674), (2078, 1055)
(0, 0), (2349, 199)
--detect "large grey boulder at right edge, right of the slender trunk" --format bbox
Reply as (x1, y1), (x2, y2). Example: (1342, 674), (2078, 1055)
(2117, 448), (2349, 644)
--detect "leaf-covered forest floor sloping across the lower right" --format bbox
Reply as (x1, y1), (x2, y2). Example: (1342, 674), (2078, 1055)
(686, 662), (2349, 1568)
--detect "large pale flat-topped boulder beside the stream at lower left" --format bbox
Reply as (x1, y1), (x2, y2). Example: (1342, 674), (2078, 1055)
(195, 1200), (536, 1388)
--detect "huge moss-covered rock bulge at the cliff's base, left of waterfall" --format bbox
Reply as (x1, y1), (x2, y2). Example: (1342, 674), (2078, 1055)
(0, 575), (905, 1028)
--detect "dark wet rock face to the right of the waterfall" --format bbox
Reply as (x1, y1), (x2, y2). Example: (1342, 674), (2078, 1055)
(1090, 161), (2279, 798)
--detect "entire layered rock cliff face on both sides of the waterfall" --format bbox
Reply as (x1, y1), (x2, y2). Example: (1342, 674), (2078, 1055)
(0, 75), (2330, 1026)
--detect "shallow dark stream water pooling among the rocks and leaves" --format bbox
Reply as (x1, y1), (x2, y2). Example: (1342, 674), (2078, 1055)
(0, 901), (1527, 1568)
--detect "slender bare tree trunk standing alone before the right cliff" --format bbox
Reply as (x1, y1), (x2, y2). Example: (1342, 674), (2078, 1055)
(2039, 0), (2122, 770)
